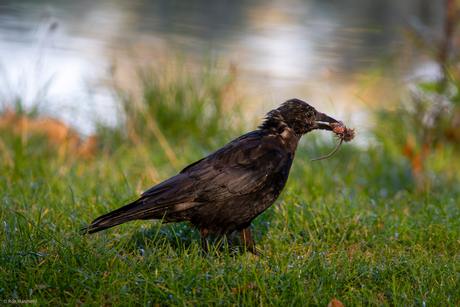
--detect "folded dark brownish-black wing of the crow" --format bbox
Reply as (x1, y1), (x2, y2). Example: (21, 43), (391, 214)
(137, 131), (286, 211)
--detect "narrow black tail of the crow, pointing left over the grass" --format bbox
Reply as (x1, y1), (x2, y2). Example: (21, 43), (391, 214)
(79, 200), (146, 235)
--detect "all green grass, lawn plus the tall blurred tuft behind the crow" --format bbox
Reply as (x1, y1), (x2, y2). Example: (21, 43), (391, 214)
(0, 54), (460, 306)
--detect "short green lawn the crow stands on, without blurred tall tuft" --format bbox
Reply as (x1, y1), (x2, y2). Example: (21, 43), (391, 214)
(0, 121), (460, 306)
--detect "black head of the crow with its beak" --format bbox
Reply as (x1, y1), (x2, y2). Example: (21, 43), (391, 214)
(260, 98), (338, 135)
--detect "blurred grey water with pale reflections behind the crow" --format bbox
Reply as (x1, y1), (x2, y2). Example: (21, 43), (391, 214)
(0, 0), (442, 133)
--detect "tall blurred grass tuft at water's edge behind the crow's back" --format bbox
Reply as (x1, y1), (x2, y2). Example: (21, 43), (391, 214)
(99, 56), (245, 150)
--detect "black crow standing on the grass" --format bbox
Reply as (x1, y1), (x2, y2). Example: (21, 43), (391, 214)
(81, 99), (338, 254)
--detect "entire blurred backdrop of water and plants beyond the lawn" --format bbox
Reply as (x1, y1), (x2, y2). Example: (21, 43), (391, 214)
(0, 0), (460, 191)
